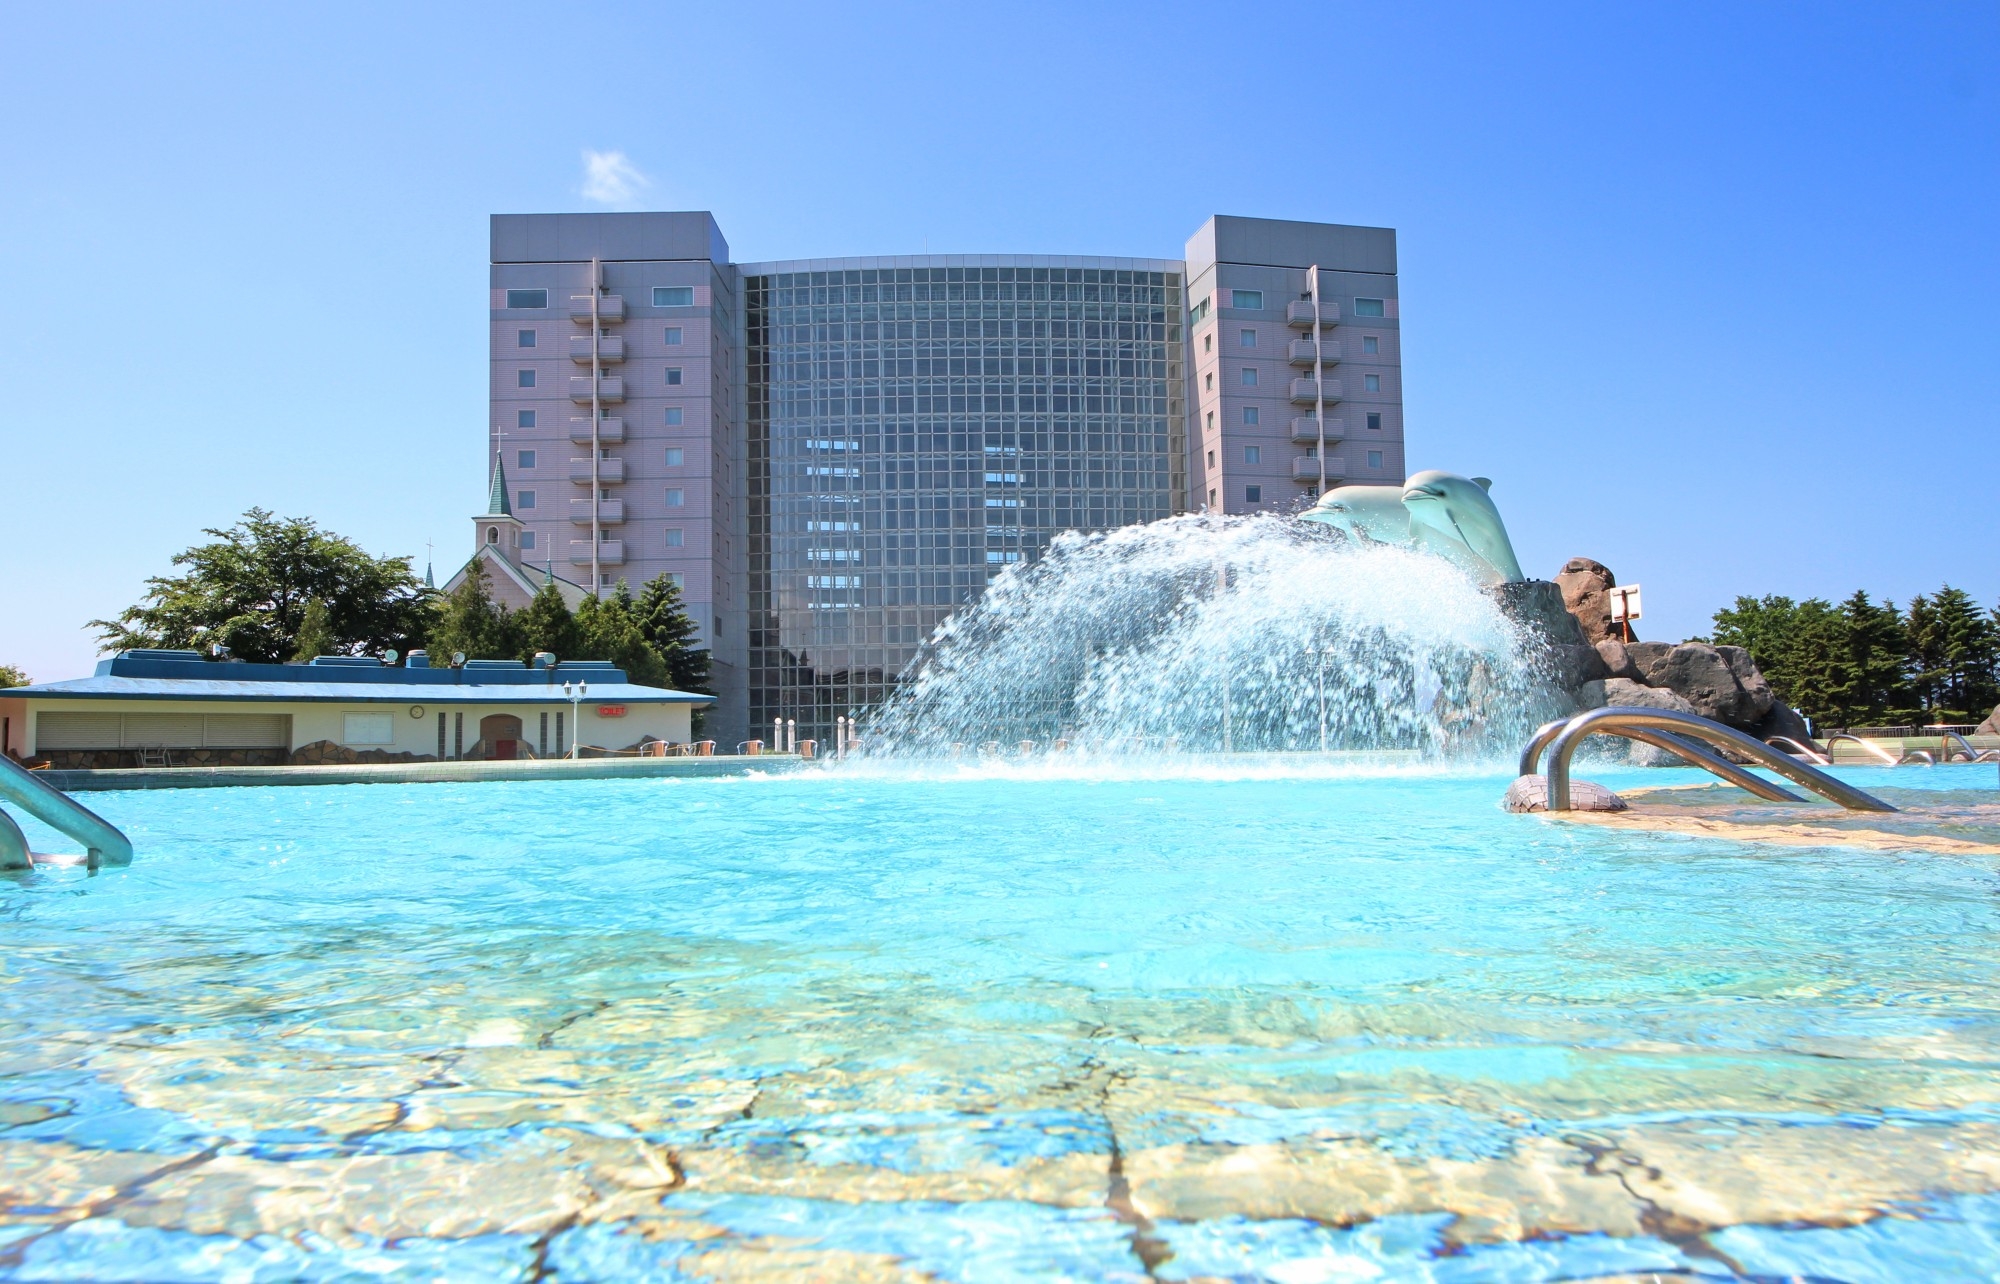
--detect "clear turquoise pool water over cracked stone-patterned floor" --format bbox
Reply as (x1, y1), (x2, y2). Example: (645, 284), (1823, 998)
(0, 764), (2000, 1284)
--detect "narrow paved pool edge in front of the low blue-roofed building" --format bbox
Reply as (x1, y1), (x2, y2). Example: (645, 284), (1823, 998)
(36, 754), (814, 794)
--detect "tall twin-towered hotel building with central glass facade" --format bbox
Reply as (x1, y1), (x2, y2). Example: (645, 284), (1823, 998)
(482, 212), (1404, 740)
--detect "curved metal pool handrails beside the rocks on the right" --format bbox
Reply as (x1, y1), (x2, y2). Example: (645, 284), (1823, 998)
(1520, 704), (1896, 812)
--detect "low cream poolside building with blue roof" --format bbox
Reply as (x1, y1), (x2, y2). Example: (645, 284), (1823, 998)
(0, 650), (712, 768)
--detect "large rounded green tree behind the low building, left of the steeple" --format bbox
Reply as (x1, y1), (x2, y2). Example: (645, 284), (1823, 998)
(90, 508), (430, 662)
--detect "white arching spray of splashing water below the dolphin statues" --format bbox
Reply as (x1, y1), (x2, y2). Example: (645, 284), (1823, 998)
(866, 516), (1560, 756)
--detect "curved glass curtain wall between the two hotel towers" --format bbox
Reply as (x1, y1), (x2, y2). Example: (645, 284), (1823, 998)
(742, 256), (1188, 742)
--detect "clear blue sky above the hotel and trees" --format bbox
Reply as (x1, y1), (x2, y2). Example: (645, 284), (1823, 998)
(0, 0), (2000, 678)
